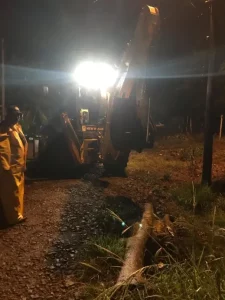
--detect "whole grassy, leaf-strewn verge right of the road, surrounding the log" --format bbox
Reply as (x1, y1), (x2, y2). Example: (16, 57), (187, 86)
(78, 138), (225, 300)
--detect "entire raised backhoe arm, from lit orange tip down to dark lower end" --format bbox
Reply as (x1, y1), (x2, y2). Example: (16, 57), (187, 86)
(102, 6), (160, 168)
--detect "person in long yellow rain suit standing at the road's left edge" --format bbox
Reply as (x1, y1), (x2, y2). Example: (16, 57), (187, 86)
(0, 106), (27, 225)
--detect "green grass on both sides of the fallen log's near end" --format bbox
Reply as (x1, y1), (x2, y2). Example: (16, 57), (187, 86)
(79, 224), (225, 300)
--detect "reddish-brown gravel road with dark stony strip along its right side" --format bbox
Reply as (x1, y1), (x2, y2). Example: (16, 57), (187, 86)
(0, 180), (109, 300)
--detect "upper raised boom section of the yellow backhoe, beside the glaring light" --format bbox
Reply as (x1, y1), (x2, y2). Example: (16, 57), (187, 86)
(116, 6), (160, 99)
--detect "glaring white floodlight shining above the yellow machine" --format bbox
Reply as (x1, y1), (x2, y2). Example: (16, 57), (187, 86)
(74, 62), (118, 91)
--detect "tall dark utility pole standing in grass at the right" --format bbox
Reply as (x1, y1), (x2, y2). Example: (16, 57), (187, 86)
(202, 0), (215, 185)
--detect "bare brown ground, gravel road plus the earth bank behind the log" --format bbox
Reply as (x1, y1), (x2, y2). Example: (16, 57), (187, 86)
(0, 138), (225, 300)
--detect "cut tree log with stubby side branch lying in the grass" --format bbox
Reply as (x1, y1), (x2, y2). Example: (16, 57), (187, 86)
(117, 203), (174, 285)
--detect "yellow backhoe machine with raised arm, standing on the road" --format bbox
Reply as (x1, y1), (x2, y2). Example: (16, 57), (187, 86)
(27, 6), (160, 176)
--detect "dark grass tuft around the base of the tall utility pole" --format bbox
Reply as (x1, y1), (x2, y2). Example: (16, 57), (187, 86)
(172, 184), (217, 212)
